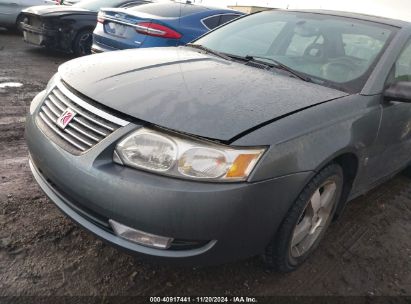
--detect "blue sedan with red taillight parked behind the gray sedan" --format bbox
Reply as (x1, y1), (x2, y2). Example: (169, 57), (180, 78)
(92, 2), (243, 53)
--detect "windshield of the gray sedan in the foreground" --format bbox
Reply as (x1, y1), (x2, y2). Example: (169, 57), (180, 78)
(195, 11), (396, 93)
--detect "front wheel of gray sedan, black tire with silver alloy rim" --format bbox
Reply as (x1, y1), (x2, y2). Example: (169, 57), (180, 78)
(263, 164), (344, 272)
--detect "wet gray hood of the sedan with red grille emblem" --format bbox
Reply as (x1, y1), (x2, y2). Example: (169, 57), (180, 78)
(59, 47), (347, 141)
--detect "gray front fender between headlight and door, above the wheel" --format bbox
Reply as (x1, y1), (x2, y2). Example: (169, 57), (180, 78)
(233, 95), (381, 181)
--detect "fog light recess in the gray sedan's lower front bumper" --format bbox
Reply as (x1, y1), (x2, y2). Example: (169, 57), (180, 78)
(109, 220), (174, 249)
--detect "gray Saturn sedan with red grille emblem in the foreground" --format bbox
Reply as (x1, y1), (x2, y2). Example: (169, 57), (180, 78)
(26, 10), (411, 272)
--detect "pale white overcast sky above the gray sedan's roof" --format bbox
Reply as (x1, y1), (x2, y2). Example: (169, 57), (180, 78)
(192, 0), (411, 21)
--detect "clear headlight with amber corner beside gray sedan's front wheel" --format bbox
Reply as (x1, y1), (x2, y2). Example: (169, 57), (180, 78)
(113, 128), (265, 182)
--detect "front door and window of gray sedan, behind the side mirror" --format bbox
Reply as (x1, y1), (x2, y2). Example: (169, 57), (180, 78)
(373, 40), (411, 177)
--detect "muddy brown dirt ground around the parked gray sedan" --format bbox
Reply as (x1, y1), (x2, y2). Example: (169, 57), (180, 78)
(0, 31), (411, 296)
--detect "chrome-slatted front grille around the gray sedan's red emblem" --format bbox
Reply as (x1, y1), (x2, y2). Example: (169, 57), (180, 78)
(38, 82), (128, 154)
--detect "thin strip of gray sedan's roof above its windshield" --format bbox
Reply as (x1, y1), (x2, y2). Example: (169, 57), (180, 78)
(270, 9), (411, 27)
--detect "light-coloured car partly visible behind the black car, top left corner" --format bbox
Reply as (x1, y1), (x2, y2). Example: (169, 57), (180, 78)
(0, 0), (57, 29)
